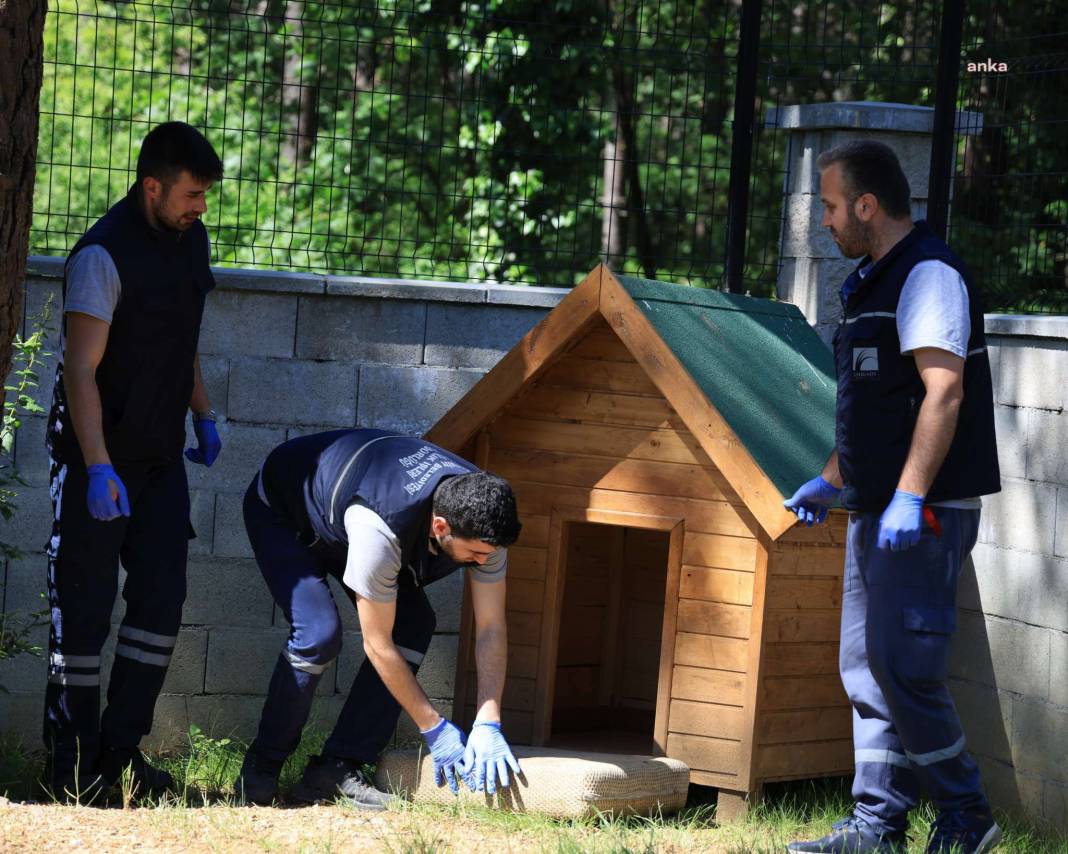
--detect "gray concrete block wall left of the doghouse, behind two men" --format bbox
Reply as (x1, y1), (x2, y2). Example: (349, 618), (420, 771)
(0, 258), (566, 748)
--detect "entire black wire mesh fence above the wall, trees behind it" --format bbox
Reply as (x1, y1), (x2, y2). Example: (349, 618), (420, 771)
(31, 0), (1068, 311)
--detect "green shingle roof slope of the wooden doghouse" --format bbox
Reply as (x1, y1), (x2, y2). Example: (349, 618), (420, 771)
(615, 275), (835, 496)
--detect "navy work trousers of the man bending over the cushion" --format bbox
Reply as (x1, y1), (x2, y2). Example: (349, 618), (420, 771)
(245, 476), (436, 763)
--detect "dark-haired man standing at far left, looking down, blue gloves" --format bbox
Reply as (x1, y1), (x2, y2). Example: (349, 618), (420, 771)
(44, 122), (222, 801)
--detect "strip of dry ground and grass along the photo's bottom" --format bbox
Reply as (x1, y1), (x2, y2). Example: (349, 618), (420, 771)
(0, 727), (1068, 854)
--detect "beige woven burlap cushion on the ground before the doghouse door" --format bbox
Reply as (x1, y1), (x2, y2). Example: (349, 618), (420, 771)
(375, 746), (690, 819)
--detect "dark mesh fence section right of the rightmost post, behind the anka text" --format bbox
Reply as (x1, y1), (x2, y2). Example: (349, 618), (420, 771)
(948, 0), (1068, 314)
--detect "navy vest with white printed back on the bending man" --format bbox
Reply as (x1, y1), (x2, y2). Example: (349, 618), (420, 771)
(263, 429), (478, 587)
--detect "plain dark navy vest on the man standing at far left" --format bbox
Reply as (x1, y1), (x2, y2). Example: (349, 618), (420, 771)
(49, 186), (215, 461)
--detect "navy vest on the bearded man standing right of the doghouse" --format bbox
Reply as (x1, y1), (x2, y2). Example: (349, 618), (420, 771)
(834, 221), (1001, 511)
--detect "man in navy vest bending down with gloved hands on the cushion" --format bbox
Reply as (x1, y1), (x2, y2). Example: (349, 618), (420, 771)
(235, 429), (520, 809)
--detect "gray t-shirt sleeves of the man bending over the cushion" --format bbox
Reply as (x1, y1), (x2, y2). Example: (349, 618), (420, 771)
(343, 504), (508, 602)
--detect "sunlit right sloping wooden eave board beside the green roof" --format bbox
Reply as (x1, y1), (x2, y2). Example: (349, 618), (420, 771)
(598, 267), (797, 540)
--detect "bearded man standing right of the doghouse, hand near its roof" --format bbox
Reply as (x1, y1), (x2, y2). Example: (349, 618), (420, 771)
(786, 141), (1001, 854)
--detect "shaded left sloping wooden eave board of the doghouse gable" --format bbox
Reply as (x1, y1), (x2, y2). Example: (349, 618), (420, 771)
(425, 264), (608, 452)
